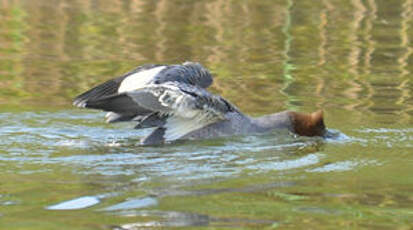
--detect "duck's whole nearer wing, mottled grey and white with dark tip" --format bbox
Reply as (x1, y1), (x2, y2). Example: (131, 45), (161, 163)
(78, 82), (237, 141)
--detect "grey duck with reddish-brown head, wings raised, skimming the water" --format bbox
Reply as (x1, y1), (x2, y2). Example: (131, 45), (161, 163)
(73, 62), (326, 145)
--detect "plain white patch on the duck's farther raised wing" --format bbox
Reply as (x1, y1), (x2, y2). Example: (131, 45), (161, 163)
(118, 66), (166, 93)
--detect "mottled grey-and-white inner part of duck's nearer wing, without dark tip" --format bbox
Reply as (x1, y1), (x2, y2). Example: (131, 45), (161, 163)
(127, 82), (238, 141)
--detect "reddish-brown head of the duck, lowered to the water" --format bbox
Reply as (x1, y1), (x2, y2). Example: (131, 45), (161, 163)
(288, 110), (326, 137)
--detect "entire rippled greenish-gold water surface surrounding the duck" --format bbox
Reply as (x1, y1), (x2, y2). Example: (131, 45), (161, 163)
(0, 0), (413, 230)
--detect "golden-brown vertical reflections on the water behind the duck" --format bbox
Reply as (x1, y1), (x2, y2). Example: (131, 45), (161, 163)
(0, 0), (411, 119)
